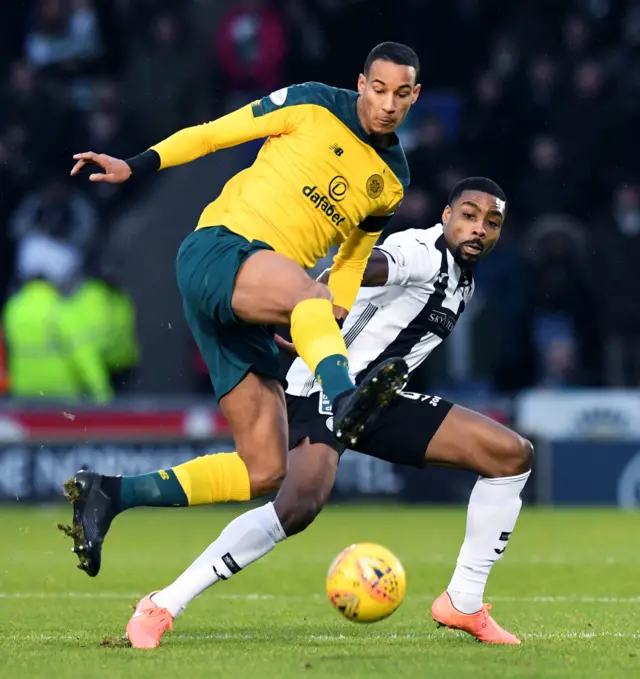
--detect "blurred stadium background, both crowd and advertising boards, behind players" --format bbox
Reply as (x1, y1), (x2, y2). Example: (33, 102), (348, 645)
(0, 0), (640, 507)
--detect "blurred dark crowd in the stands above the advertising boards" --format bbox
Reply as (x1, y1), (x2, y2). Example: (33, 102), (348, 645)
(0, 0), (640, 400)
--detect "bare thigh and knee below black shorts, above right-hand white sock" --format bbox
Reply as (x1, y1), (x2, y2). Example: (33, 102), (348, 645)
(426, 405), (533, 478)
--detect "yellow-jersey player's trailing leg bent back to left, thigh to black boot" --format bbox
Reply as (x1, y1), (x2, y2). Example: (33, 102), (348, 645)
(59, 373), (288, 577)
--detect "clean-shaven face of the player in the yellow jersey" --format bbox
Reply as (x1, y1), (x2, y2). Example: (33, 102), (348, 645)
(358, 59), (420, 134)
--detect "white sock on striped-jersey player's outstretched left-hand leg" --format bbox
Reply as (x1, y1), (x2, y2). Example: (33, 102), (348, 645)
(153, 502), (287, 617)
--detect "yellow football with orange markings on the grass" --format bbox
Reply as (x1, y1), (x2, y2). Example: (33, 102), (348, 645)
(327, 542), (407, 622)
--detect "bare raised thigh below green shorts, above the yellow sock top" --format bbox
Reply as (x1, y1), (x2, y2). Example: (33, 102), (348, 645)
(232, 250), (331, 325)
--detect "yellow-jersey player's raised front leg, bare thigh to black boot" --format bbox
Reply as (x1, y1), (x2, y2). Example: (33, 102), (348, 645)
(232, 250), (408, 445)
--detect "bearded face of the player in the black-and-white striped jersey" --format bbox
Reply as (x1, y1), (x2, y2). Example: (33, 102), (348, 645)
(442, 191), (506, 268)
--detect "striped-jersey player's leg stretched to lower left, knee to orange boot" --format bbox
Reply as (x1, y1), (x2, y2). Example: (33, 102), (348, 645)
(122, 439), (338, 648)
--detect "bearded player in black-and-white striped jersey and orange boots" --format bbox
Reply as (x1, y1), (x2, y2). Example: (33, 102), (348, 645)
(79, 177), (533, 648)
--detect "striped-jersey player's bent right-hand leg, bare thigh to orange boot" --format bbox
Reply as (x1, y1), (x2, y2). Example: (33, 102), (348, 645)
(425, 406), (533, 644)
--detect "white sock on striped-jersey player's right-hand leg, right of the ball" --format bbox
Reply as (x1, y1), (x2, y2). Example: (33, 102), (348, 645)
(447, 471), (531, 613)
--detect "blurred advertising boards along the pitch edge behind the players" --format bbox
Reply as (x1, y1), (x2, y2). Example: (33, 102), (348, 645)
(0, 390), (640, 508)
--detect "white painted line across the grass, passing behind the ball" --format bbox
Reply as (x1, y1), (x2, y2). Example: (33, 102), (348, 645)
(0, 592), (640, 604)
